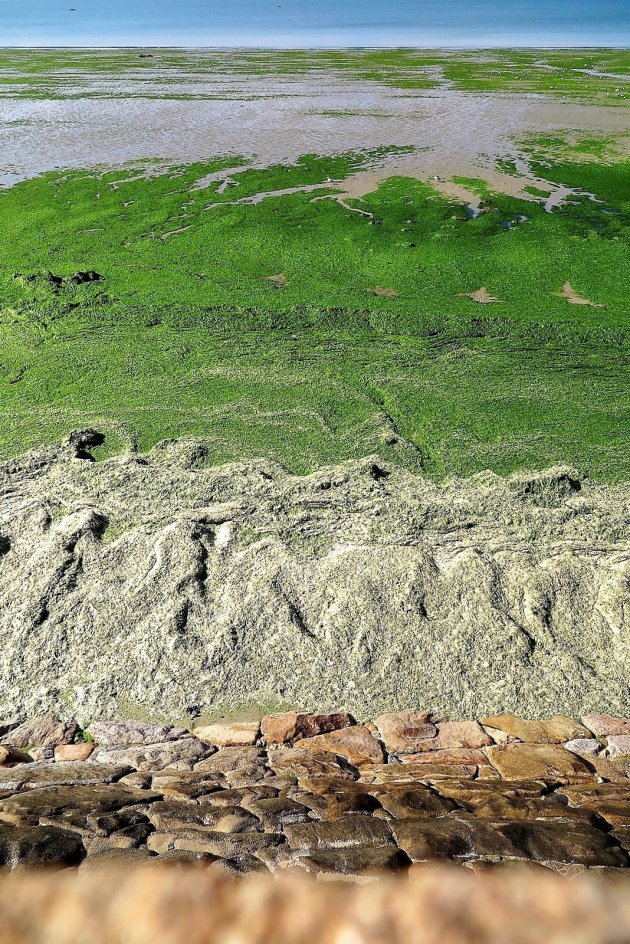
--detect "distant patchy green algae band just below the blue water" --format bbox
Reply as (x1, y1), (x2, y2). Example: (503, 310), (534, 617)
(0, 48), (630, 105)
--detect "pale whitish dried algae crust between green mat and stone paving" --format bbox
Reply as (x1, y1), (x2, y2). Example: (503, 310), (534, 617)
(0, 440), (630, 720)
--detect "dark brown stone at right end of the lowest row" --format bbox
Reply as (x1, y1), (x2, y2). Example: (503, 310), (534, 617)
(497, 820), (628, 866)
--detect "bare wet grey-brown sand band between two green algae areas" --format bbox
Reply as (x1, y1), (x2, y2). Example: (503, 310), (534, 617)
(0, 62), (627, 194)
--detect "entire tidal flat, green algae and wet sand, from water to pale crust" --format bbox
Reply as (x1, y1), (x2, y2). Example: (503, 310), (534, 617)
(0, 50), (630, 480)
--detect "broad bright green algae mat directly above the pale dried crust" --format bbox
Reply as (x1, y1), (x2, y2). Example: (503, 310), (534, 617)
(0, 139), (630, 481)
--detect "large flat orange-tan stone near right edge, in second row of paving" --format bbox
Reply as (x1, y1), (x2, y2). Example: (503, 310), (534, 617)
(486, 743), (592, 781)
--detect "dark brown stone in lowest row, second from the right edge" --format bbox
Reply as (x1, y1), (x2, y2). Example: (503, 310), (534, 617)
(390, 814), (523, 862)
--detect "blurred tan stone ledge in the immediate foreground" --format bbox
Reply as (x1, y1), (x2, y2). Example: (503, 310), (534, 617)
(0, 863), (630, 944)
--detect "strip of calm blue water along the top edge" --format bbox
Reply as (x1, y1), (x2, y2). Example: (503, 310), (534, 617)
(0, 0), (630, 48)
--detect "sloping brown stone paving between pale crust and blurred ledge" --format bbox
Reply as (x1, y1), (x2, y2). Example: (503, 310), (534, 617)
(0, 711), (630, 880)
